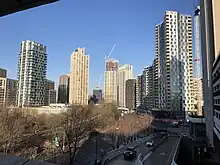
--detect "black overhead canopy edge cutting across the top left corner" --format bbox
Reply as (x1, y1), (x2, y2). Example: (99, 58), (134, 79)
(0, 0), (58, 17)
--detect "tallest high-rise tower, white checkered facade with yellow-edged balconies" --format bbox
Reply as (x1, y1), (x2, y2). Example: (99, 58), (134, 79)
(156, 11), (194, 113)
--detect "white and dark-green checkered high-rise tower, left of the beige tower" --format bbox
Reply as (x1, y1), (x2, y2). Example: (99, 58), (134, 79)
(18, 40), (47, 107)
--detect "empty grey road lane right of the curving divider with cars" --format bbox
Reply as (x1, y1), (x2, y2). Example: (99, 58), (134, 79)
(144, 137), (179, 165)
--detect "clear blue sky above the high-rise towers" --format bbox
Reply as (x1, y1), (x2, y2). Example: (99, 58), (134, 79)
(0, 0), (193, 92)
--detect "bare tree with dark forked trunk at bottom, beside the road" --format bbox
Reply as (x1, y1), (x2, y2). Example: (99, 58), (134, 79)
(51, 105), (101, 165)
